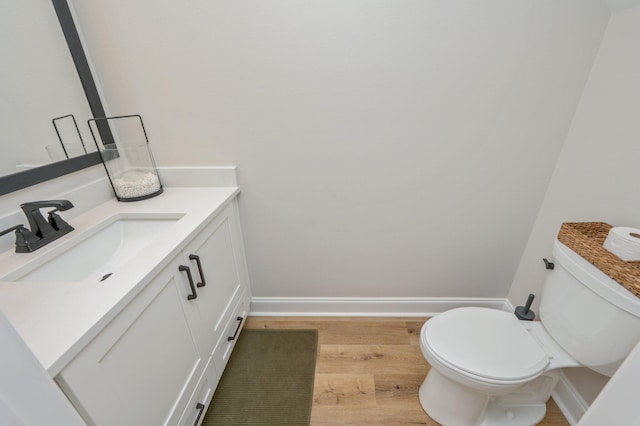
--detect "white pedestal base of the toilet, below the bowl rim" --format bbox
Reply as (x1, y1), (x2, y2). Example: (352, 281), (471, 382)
(419, 368), (547, 426)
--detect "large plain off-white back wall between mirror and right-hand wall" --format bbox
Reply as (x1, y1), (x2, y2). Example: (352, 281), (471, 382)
(73, 0), (609, 297)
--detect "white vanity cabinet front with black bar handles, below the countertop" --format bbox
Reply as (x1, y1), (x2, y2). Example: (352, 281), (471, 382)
(56, 200), (250, 426)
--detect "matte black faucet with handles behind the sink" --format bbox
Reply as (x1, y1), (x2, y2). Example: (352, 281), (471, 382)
(0, 200), (73, 253)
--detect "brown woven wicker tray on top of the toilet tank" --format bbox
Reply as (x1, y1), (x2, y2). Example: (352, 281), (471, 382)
(558, 222), (640, 297)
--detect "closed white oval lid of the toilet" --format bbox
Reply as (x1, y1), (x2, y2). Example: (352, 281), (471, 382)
(423, 308), (549, 381)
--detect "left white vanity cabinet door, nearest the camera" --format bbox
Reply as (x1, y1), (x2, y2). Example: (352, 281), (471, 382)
(56, 259), (209, 426)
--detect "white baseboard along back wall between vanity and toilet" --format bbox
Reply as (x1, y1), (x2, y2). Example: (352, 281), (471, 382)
(251, 297), (506, 317)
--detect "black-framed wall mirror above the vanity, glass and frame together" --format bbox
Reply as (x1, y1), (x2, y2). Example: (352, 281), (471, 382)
(0, 0), (105, 195)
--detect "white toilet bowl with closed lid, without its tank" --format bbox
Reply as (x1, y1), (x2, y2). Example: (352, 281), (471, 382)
(419, 307), (580, 426)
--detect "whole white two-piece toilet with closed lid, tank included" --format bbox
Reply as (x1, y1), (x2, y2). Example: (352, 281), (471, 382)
(419, 239), (640, 426)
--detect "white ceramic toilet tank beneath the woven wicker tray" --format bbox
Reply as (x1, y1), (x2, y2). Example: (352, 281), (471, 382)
(540, 239), (640, 376)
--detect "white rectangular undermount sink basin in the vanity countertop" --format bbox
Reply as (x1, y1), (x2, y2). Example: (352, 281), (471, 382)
(4, 217), (180, 282)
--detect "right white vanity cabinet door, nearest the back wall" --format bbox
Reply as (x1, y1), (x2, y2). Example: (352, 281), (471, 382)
(182, 204), (246, 355)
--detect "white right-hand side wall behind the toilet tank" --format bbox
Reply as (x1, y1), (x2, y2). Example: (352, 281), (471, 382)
(509, 2), (640, 416)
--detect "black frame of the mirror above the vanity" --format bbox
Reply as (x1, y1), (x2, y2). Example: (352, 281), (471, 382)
(0, 0), (106, 195)
